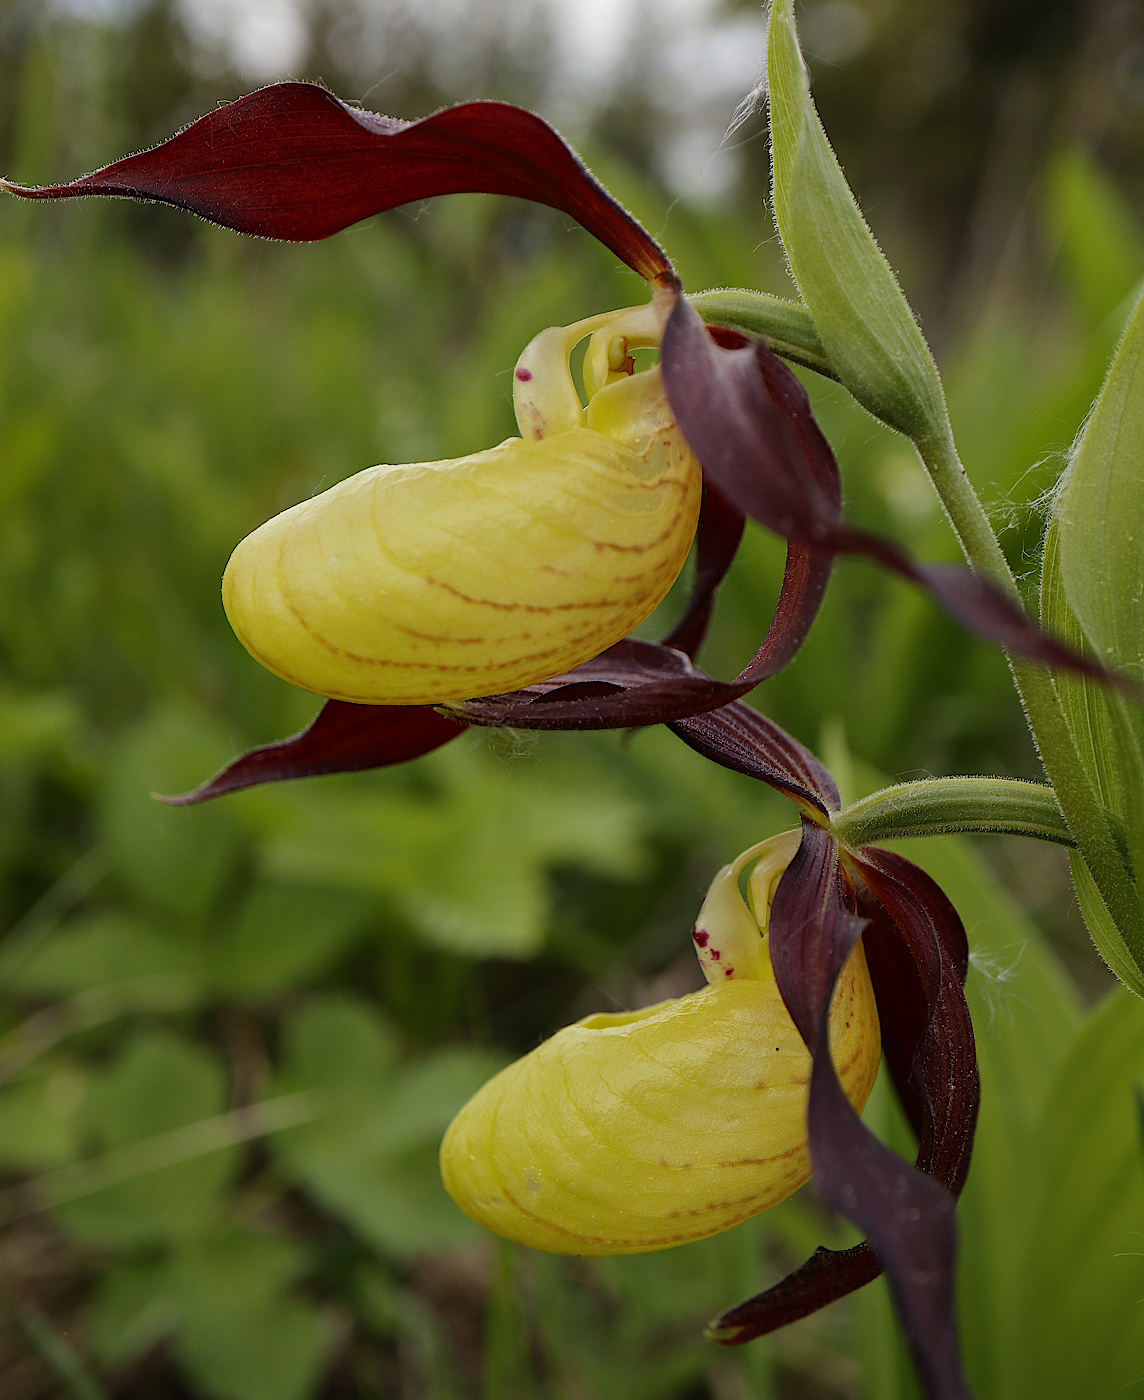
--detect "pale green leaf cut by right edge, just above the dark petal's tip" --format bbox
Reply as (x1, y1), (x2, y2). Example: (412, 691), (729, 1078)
(1054, 284), (1144, 679)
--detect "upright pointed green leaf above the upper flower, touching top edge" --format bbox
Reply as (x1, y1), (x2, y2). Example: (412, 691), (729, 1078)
(767, 0), (949, 442)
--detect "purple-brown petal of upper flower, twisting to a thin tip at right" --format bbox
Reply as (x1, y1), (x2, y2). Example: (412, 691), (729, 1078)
(661, 297), (1136, 689)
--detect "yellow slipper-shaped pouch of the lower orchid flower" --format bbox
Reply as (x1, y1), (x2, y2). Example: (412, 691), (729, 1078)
(441, 833), (881, 1254)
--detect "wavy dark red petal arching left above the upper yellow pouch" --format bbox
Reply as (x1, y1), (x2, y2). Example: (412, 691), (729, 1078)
(7, 83), (671, 281)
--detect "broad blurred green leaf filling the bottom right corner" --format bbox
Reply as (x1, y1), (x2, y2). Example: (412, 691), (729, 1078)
(998, 990), (1144, 1400)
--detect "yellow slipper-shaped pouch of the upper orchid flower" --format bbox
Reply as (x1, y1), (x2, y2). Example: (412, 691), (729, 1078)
(223, 301), (702, 704)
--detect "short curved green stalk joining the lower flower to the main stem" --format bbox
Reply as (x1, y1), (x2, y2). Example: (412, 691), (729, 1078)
(830, 777), (1077, 847)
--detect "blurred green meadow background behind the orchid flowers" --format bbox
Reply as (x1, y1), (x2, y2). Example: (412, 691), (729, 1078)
(0, 0), (1144, 1400)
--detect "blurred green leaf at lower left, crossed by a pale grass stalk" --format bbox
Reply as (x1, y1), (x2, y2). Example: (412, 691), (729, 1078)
(56, 1032), (235, 1246)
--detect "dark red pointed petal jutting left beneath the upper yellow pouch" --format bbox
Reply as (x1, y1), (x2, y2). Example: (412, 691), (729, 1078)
(160, 700), (465, 806)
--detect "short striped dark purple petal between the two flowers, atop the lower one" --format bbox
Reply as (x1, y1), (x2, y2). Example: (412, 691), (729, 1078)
(671, 700), (839, 815)
